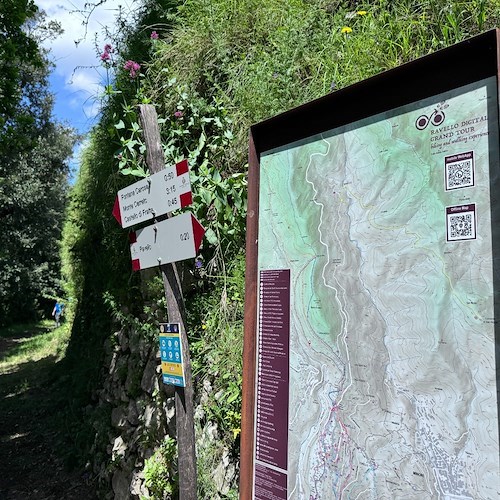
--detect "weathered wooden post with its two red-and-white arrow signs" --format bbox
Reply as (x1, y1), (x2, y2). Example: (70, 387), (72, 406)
(113, 104), (199, 500)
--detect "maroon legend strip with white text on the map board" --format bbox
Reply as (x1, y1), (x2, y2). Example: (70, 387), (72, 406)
(255, 269), (290, 492)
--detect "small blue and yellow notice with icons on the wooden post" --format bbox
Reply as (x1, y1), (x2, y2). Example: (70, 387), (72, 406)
(160, 323), (186, 387)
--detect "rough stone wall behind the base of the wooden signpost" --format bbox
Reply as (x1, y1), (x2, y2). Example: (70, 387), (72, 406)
(90, 328), (238, 500)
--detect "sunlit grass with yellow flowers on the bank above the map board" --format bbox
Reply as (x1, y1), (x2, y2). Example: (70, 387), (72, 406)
(146, 0), (500, 171)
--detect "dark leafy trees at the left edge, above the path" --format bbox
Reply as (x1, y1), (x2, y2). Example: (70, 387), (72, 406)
(0, 0), (76, 325)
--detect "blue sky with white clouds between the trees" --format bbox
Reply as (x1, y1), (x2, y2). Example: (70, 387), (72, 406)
(35, 0), (135, 152)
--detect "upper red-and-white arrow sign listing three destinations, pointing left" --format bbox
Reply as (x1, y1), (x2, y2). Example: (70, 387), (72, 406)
(113, 160), (193, 227)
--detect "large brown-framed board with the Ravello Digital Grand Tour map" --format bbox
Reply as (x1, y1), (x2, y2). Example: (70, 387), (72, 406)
(240, 31), (500, 500)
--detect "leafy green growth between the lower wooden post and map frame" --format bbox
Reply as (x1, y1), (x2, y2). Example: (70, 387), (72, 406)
(188, 253), (245, 492)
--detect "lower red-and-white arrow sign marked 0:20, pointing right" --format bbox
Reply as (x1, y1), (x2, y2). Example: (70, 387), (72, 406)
(130, 213), (205, 271)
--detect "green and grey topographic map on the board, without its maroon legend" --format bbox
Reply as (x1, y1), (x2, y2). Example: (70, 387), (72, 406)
(258, 79), (500, 500)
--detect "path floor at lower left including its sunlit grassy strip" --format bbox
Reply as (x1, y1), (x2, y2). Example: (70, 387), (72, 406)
(0, 320), (95, 500)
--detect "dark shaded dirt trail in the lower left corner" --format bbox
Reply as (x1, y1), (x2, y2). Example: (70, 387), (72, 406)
(0, 331), (97, 500)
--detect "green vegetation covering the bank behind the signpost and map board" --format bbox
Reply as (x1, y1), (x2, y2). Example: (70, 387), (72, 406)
(59, 0), (500, 498)
